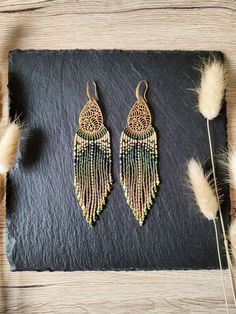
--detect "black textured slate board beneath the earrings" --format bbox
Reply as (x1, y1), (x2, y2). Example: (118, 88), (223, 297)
(7, 50), (229, 271)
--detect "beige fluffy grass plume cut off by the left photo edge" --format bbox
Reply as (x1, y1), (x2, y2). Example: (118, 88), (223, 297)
(0, 122), (21, 173)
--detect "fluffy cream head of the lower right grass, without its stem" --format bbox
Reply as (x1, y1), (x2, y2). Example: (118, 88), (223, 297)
(188, 158), (218, 220)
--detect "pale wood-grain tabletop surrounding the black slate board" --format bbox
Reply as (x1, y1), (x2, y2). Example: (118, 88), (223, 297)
(0, 0), (236, 313)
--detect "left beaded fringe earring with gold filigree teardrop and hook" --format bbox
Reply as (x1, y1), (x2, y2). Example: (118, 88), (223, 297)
(74, 82), (112, 226)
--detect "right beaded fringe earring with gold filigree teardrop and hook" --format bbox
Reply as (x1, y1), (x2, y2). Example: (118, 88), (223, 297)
(120, 80), (160, 225)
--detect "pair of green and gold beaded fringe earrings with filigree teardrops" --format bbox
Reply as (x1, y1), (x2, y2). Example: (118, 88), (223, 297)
(74, 80), (159, 225)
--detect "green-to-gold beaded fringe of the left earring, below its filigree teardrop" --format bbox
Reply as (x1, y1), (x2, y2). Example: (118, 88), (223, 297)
(74, 127), (112, 225)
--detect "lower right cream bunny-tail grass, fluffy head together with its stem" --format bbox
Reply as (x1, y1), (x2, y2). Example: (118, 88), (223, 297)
(188, 158), (229, 313)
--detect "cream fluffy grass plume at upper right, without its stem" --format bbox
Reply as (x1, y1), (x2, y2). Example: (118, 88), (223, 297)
(196, 58), (226, 120)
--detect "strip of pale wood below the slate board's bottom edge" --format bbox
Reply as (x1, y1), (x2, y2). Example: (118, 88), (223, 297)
(3, 271), (236, 313)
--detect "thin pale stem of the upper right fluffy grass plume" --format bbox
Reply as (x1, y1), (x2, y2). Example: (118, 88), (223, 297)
(207, 119), (236, 307)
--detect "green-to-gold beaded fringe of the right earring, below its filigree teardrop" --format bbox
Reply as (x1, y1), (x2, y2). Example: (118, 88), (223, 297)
(120, 127), (160, 225)
